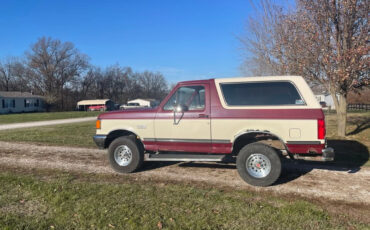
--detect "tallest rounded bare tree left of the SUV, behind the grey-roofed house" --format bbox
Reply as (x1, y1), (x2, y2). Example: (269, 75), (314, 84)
(26, 37), (88, 109)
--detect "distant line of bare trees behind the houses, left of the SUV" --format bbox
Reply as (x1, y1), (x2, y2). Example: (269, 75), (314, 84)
(0, 37), (168, 110)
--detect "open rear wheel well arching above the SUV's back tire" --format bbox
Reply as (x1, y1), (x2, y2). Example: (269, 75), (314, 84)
(232, 132), (287, 155)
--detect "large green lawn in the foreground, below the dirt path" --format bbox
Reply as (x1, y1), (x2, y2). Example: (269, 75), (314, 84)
(0, 168), (369, 229)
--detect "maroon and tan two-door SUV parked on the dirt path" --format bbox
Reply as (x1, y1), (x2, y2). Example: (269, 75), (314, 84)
(94, 76), (334, 186)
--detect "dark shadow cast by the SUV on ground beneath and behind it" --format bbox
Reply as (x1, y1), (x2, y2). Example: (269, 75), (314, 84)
(140, 140), (370, 185)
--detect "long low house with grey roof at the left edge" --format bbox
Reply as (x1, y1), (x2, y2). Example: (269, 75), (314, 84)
(0, 91), (45, 114)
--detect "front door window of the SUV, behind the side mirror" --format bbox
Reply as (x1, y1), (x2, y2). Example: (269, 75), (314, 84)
(163, 86), (205, 111)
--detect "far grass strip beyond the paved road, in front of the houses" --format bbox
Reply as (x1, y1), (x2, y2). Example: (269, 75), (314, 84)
(0, 111), (101, 124)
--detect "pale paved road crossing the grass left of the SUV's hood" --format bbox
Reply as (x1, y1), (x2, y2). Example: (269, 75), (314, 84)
(0, 117), (96, 130)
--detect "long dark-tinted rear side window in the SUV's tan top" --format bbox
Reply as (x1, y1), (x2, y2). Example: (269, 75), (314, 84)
(221, 82), (304, 106)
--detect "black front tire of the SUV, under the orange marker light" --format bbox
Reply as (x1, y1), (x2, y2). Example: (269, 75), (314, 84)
(108, 136), (144, 173)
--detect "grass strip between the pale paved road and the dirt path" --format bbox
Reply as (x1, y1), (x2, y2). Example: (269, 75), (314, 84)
(0, 121), (96, 147)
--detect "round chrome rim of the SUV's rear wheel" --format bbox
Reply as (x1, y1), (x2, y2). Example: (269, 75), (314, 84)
(246, 153), (271, 178)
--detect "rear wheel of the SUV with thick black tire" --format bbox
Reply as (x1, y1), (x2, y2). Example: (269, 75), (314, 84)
(236, 143), (281, 187)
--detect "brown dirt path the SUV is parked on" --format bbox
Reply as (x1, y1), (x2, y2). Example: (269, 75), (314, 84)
(0, 142), (370, 205)
